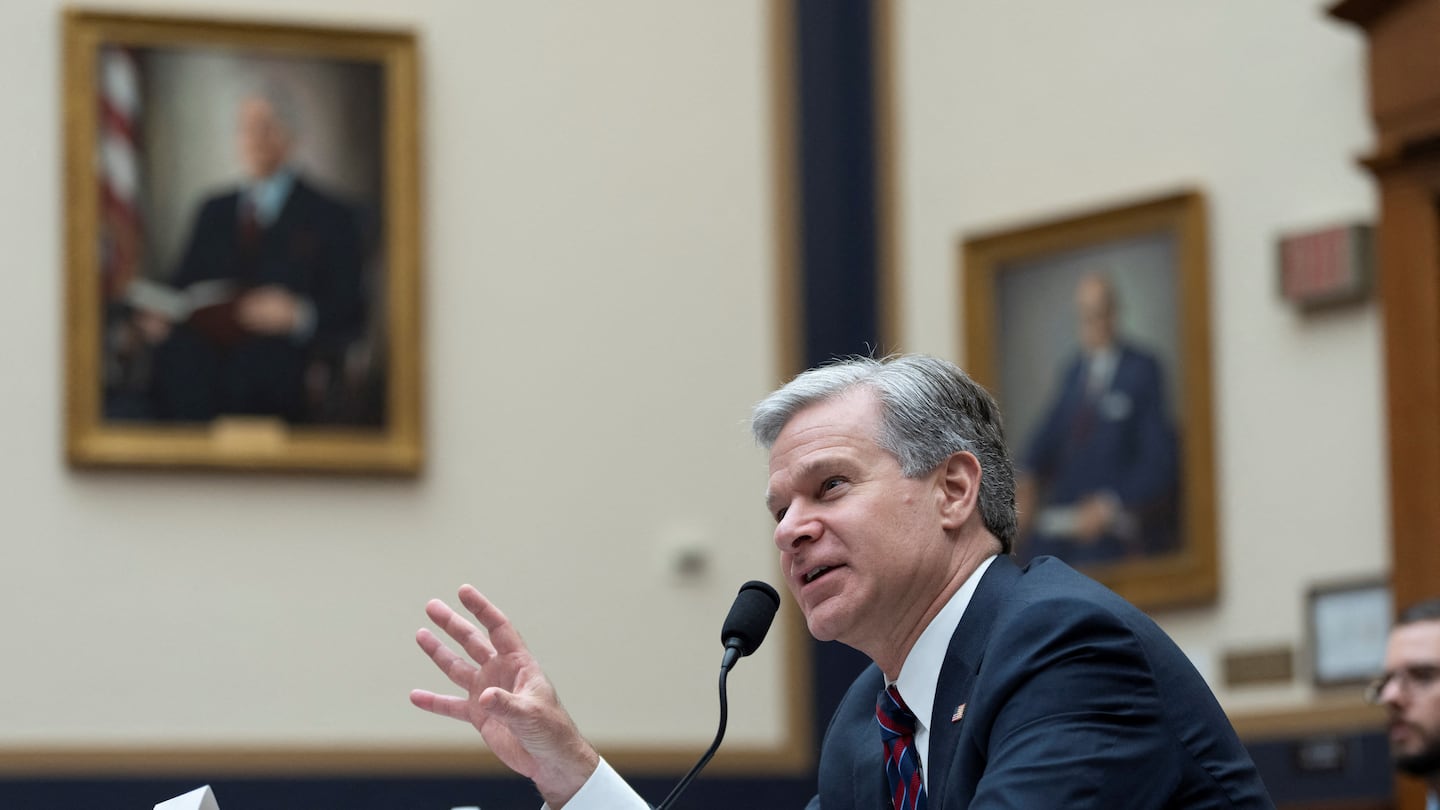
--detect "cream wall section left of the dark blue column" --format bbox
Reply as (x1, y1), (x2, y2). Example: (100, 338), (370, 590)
(0, 0), (785, 748)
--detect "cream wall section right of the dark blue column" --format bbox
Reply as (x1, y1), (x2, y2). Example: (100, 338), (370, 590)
(896, 0), (1388, 712)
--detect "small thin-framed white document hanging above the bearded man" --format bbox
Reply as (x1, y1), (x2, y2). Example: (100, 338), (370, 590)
(1306, 578), (1391, 686)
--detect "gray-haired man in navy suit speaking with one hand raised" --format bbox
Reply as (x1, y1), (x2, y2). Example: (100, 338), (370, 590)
(410, 356), (1273, 810)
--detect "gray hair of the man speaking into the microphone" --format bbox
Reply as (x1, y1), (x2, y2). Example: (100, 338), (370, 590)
(750, 355), (1015, 553)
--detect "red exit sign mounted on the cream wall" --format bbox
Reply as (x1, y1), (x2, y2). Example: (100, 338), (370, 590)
(1280, 225), (1374, 307)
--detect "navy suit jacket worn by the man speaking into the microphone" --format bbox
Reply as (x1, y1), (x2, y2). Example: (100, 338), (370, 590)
(809, 556), (1274, 810)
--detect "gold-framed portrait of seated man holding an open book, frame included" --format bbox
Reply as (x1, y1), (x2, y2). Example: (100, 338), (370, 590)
(63, 10), (422, 474)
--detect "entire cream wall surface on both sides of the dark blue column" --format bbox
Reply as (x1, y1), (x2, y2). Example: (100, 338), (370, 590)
(0, 0), (1388, 747)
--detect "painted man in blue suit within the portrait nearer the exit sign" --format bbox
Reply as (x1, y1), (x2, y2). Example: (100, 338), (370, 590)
(1017, 274), (1179, 564)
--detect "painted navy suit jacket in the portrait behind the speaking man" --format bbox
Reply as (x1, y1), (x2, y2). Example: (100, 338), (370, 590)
(1021, 344), (1179, 562)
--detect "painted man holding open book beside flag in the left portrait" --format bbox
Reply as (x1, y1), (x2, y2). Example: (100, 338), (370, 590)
(137, 88), (364, 422)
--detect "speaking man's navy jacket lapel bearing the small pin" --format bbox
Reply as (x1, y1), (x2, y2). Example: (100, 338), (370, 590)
(926, 555), (1021, 807)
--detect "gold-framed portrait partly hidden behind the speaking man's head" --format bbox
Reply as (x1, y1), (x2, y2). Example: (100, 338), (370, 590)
(959, 192), (1218, 608)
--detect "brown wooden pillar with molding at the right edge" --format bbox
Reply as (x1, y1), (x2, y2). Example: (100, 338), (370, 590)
(1331, 0), (1440, 810)
